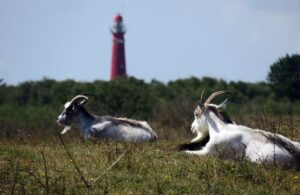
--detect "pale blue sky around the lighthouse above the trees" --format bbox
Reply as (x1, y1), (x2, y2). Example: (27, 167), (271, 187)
(0, 0), (300, 84)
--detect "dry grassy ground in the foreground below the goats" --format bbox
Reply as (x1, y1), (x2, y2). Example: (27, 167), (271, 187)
(0, 128), (300, 194)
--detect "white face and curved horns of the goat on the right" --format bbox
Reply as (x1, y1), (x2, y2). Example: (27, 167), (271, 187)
(191, 91), (232, 134)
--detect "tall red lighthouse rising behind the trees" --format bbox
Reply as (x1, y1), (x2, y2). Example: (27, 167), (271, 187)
(110, 14), (126, 80)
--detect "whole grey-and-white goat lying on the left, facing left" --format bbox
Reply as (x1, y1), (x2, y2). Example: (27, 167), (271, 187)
(57, 95), (157, 142)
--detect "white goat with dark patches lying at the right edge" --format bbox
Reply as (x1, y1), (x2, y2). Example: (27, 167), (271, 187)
(179, 91), (300, 170)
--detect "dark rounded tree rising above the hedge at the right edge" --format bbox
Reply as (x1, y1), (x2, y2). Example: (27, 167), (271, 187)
(267, 55), (300, 101)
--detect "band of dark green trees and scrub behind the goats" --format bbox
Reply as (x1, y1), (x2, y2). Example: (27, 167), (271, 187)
(0, 55), (300, 138)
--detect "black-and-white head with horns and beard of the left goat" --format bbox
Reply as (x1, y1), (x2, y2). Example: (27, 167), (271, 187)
(56, 95), (88, 134)
